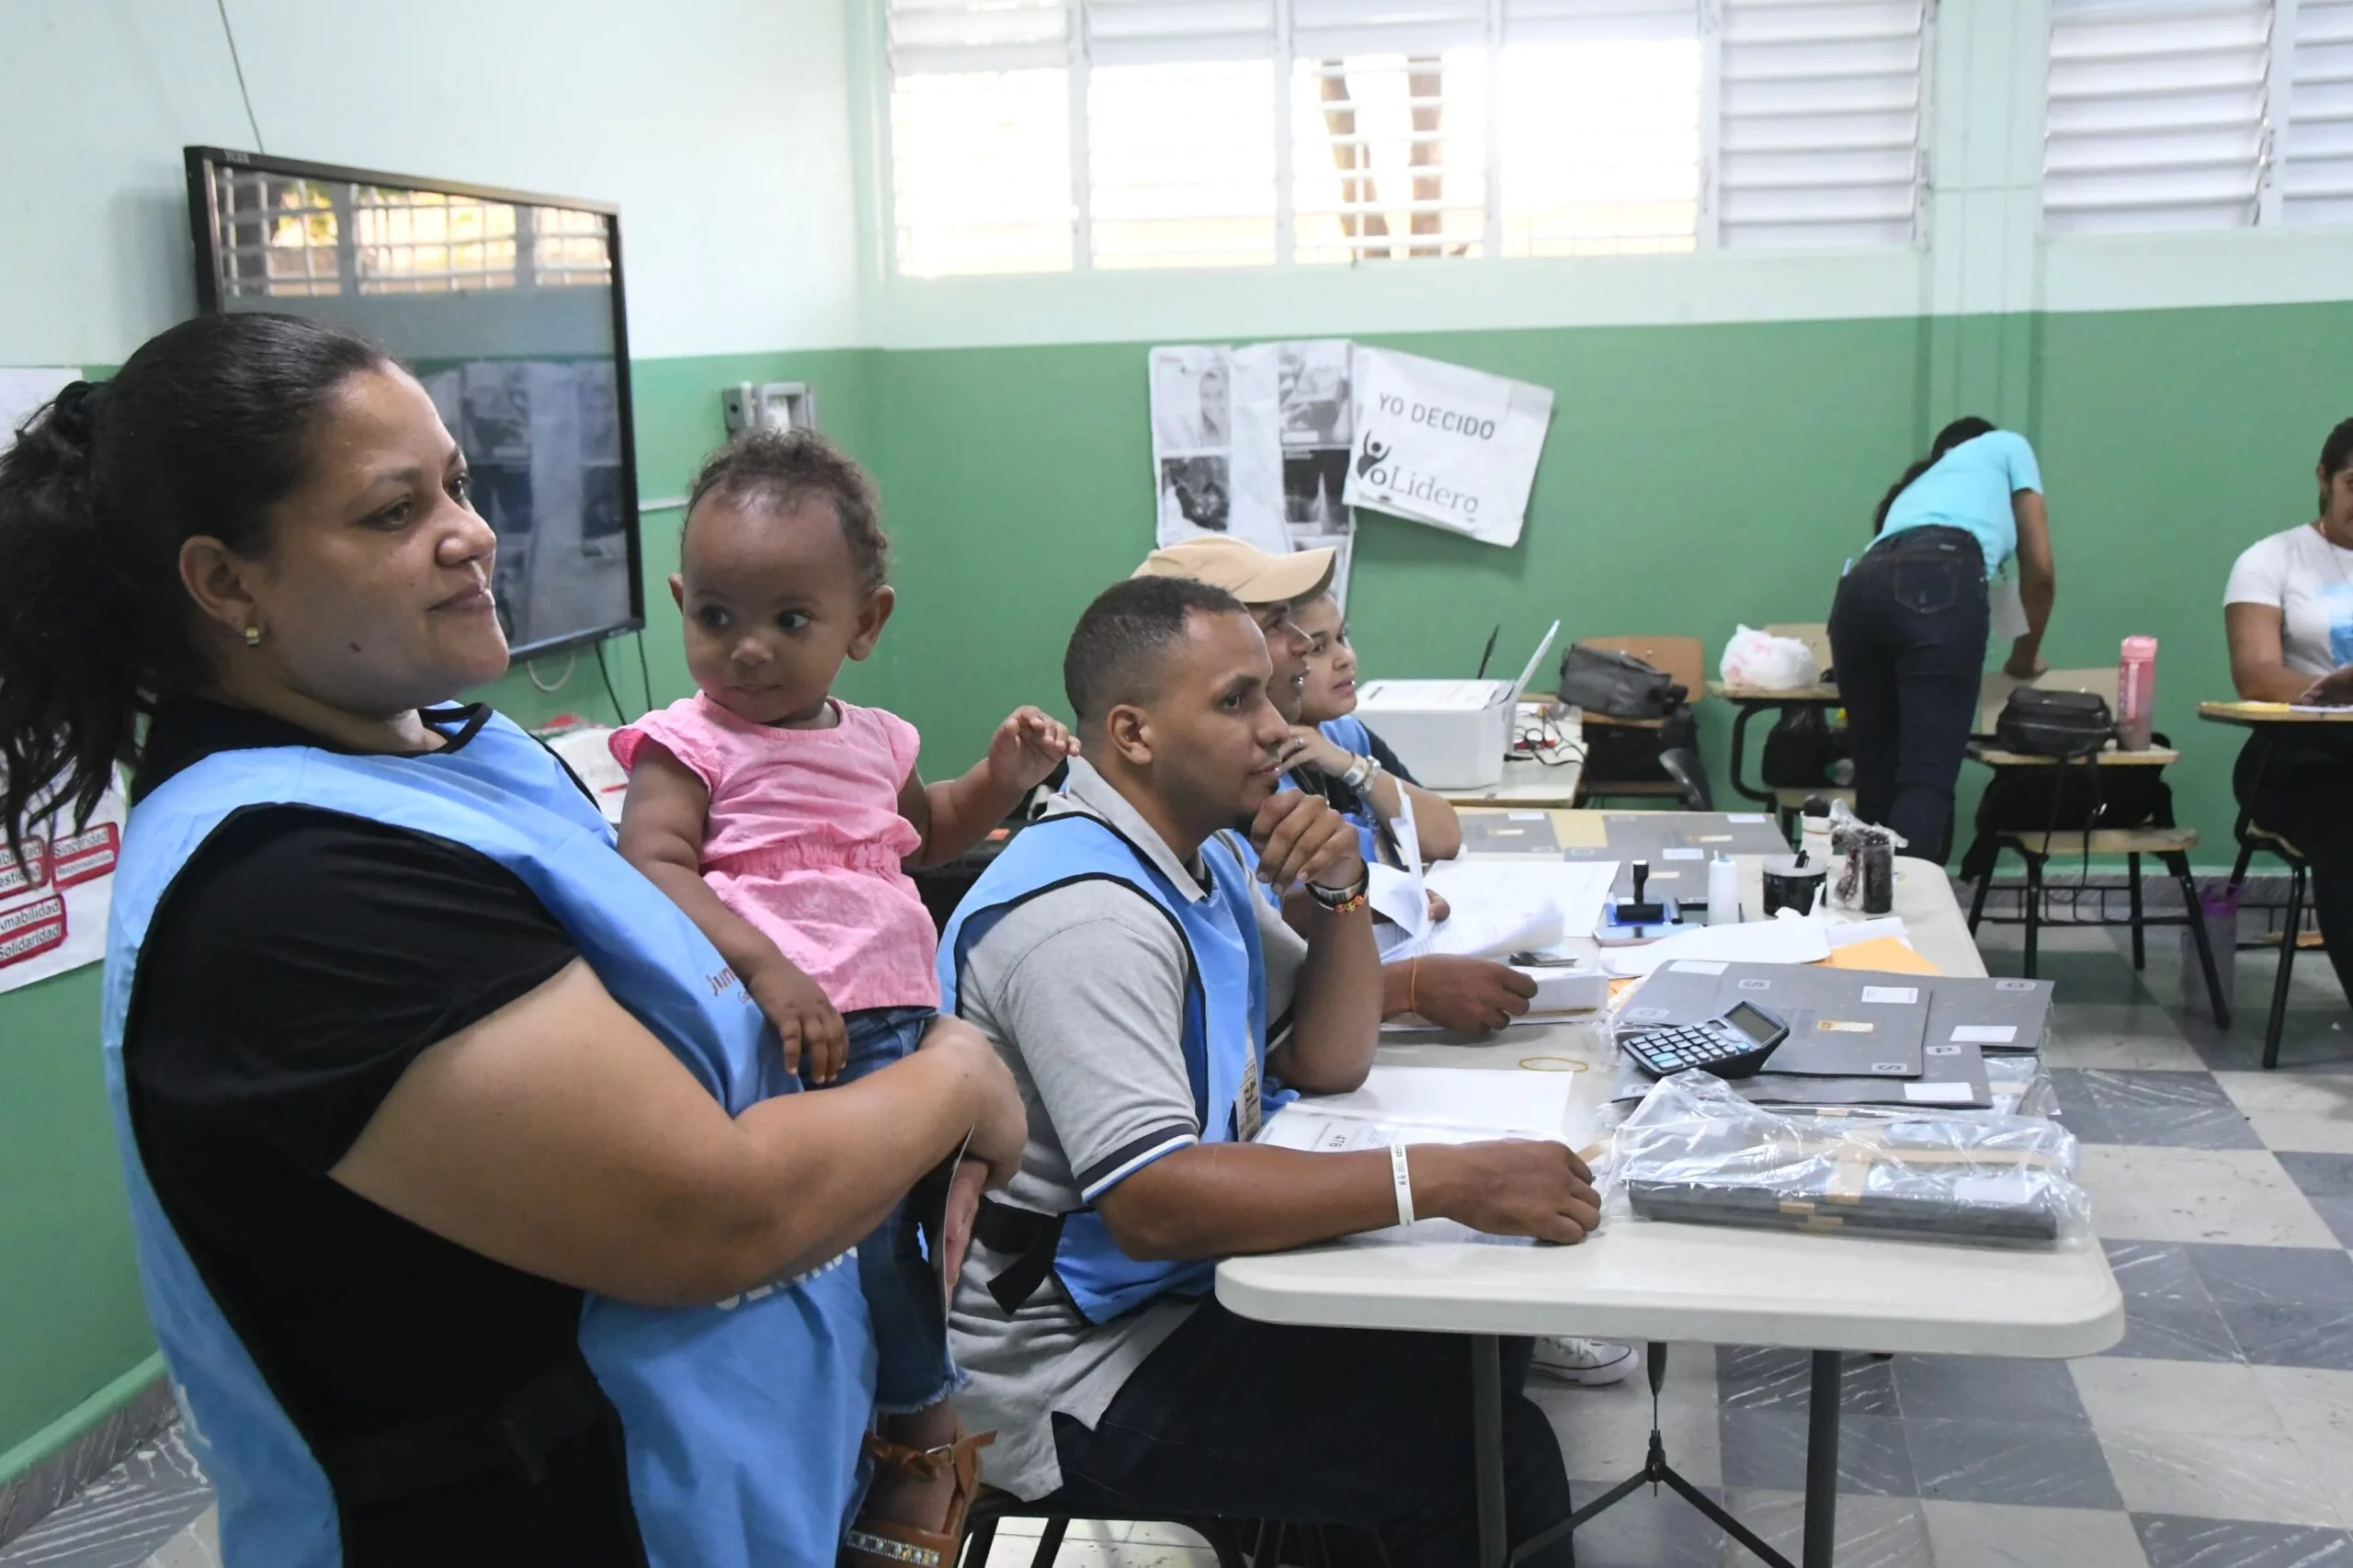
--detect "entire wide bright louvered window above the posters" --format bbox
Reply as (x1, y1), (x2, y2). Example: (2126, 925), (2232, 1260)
(885, 0), (1929, 276)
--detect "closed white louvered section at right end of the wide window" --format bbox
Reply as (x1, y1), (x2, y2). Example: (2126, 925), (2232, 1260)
(1715, 0), (1929, 247)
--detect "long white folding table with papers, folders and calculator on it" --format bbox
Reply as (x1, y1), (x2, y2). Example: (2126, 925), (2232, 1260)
(1217, 859), (2125, 1568)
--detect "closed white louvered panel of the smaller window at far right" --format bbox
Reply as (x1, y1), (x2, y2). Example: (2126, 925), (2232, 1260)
(2042, 0), (2273, 233)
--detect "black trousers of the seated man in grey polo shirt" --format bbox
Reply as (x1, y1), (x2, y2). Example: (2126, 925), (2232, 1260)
(1050, 1300), (1574, 1568)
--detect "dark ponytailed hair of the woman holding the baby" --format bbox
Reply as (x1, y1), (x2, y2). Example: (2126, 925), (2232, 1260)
(0, 313), (391, 852)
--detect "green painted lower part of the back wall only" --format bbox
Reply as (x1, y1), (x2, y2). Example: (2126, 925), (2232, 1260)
(873, 303), (2353, 864)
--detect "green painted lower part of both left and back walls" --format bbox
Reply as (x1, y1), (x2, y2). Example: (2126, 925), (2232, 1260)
(0, 303), (2353, 1476)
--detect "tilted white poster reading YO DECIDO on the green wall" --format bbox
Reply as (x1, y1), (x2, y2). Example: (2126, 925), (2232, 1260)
(1344, 348), (1553, 546)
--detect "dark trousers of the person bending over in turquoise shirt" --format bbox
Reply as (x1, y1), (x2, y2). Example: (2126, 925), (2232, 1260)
(1831, 528), (1991, 862)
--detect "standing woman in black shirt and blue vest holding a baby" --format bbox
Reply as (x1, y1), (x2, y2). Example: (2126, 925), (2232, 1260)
(0, 315), (1026, 1568)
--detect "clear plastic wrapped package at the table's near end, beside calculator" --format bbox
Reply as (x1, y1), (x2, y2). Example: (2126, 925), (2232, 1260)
(1609, 1072), (2092, 1248)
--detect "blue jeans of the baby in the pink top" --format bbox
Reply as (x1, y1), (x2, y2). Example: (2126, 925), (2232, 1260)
(837, 1007), (965, 1415)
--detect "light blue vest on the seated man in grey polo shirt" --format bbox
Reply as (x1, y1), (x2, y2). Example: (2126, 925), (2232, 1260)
(938, 812), (1266, 1324)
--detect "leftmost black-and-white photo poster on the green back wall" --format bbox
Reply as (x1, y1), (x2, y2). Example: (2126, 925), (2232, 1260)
(1146, 344), (1291, 553)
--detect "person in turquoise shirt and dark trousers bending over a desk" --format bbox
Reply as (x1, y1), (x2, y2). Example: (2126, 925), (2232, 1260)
(1831, 416), (2056, 862)
